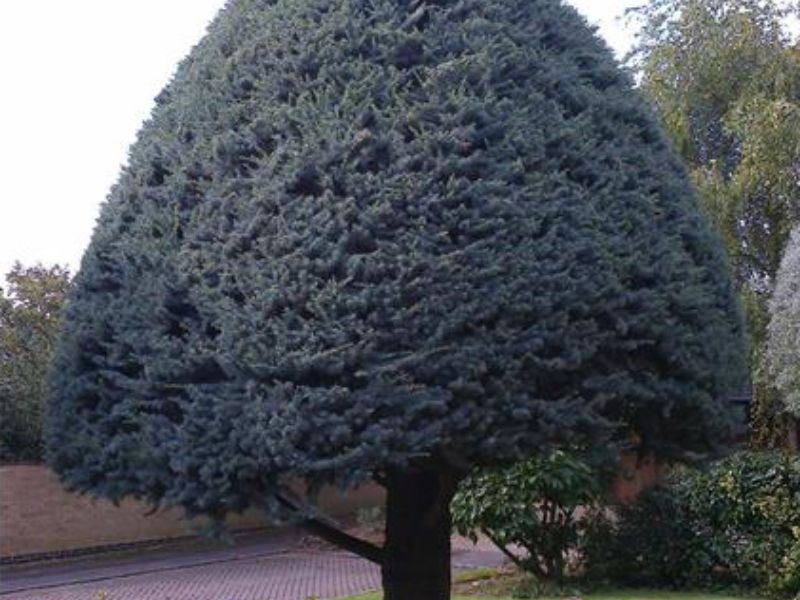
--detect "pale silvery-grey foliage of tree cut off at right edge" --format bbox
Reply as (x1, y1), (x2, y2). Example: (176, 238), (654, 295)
(769, 227), (800, 418)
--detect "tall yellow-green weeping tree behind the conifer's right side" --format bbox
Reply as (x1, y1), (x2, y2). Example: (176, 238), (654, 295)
(631, 0), (800, 446)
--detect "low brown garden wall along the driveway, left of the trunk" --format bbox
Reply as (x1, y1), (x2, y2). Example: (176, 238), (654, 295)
(0, 465), (382, 558)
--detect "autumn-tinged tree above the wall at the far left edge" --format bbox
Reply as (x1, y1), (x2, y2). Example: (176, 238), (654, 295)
(0, 263), (70, 460)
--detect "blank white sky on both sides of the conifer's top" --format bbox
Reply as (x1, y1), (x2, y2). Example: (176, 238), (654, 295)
(0, 0), (637, 283)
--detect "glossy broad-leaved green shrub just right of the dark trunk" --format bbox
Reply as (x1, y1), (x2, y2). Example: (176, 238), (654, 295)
(453, 450), (600, 581)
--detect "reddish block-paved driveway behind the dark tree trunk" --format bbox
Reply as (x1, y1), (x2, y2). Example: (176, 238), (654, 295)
(0, 531), (503, 600)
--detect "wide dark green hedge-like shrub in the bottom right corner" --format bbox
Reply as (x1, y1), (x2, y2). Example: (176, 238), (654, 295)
(586, 452), (800, 596)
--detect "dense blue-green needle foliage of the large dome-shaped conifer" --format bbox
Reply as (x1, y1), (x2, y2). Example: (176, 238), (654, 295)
(49, 0), (743, 515)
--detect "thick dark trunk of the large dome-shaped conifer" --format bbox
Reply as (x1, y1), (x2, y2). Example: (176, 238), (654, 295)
(382, 470), (457, 600)
